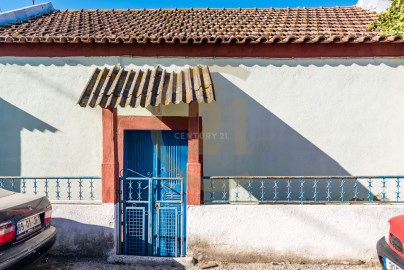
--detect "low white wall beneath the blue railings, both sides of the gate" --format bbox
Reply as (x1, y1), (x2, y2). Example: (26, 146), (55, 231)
(45, 204), (404, 263)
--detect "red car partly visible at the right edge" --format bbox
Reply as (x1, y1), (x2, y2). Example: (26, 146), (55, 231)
(377, 215), (404, 270)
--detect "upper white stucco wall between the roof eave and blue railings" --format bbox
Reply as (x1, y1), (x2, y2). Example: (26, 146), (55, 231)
(0, 57), (404, 198)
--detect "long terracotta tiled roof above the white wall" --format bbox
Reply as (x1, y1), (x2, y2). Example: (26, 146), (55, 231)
(0, 6), (404, 43)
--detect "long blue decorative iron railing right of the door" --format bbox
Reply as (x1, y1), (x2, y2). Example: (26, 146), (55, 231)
(203, 176), (404, 204)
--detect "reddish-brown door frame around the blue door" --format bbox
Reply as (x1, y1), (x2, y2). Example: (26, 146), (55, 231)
(101, 102), (203, 254)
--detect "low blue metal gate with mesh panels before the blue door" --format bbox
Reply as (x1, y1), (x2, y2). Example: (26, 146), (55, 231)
(118, 176), (186, 257)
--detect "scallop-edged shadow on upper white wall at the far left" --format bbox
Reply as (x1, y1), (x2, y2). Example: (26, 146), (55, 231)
(0, 98), (58, 177)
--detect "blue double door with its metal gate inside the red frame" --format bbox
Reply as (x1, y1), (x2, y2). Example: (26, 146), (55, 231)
(119, 130), (188, 257)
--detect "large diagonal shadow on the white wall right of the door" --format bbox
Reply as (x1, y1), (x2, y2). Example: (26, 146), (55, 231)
(201, 72), (376, 200)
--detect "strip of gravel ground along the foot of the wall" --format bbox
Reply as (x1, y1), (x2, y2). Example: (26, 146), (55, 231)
(36, 258), (381, 270)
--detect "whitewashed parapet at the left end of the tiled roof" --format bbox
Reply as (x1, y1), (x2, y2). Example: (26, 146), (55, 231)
(0, 2), (55, 26)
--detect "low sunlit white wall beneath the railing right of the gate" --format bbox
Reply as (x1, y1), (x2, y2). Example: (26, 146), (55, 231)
(187, 205), (403, 263)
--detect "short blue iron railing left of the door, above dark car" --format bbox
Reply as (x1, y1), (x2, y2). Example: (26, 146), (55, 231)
(0, 176), (101, 203)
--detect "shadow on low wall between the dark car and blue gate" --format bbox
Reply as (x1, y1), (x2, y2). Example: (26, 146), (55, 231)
(50, 218), (114, 257)
